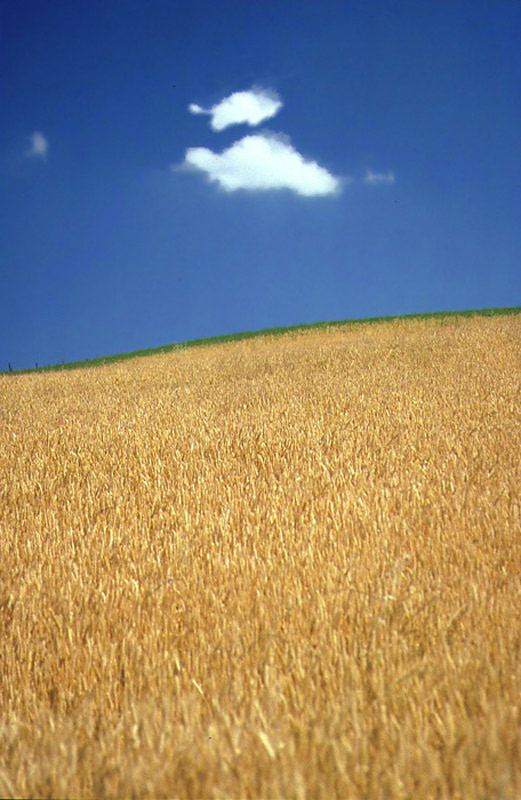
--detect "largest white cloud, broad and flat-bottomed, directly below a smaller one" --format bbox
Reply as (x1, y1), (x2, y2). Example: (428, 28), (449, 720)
(179, 132), (342, 197)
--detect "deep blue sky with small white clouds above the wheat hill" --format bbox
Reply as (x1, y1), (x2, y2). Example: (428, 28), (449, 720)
(0, 0), (521, 369)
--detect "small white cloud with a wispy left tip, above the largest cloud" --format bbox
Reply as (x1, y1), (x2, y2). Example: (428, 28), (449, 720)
(188, 86), (283, 131)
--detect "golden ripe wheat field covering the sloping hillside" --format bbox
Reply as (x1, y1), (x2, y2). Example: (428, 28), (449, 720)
(0, 316), (521, 800)
